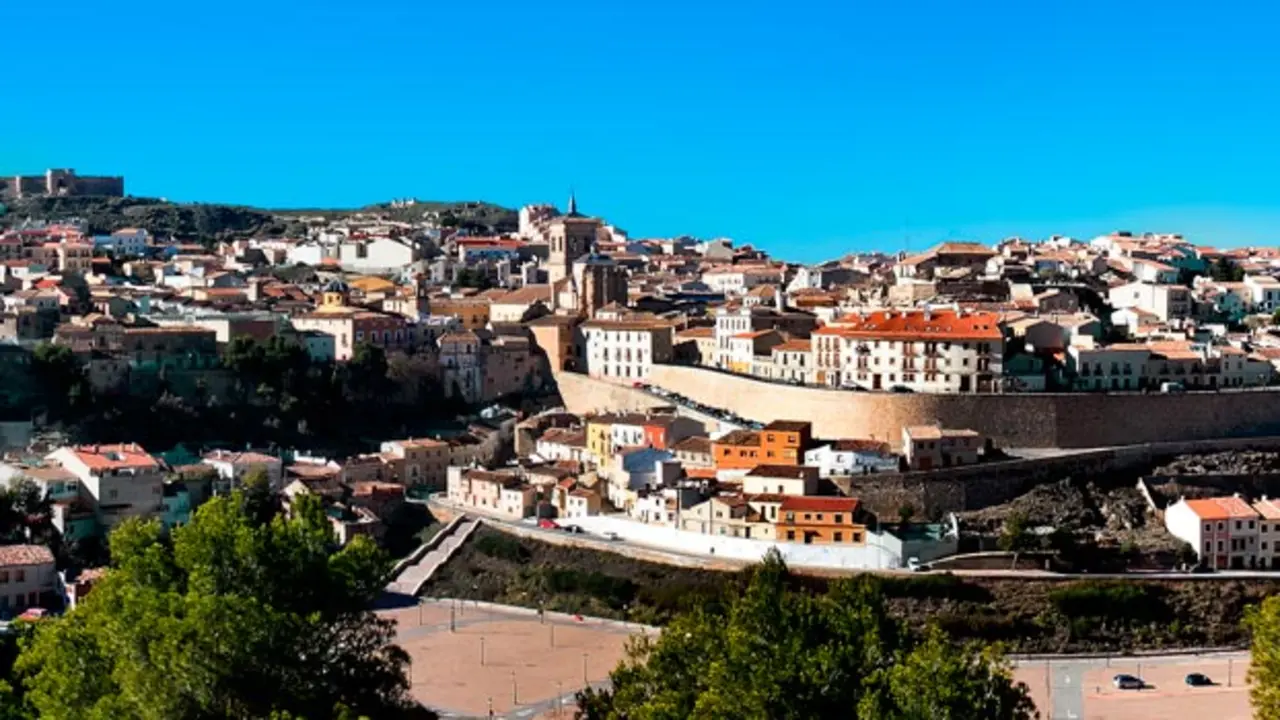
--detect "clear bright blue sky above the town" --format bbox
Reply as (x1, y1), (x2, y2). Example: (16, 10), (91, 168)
(0, 0), (1280, 259)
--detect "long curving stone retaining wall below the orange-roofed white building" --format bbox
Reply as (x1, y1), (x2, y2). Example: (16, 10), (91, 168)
(637, 365), (1280, 448)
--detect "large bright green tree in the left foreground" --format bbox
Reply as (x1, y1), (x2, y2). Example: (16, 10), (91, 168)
(15, 492), (411, 720)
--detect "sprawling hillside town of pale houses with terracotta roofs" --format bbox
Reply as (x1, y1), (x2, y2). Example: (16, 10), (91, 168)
(0, 176), (1280, 604)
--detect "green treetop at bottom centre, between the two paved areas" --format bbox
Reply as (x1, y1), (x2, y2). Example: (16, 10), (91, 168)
(579, 553), (1034, 720)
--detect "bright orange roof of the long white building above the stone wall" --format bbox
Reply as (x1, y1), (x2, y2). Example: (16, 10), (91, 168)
(814, 310), (1004, 341)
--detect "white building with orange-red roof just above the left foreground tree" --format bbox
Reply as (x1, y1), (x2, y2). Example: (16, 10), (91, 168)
(46, 443), (164, 530)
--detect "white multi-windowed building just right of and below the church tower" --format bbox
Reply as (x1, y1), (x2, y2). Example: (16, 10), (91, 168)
(582, 315), (675, 383)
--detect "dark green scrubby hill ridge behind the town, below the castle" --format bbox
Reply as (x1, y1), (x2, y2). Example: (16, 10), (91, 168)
(0, 197), (517, 242)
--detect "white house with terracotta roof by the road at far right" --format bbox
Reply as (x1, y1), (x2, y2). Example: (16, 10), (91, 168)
(1165, 496), (1274, 570)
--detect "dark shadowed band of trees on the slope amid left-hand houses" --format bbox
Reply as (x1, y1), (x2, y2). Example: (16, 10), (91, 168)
(17, 337), (481, 454)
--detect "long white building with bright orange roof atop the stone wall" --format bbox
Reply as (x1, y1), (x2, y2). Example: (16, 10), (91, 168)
(813, 304), (1005, 393)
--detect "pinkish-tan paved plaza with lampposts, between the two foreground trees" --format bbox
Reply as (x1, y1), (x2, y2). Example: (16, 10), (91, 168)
(379, 600), (644, 719)
